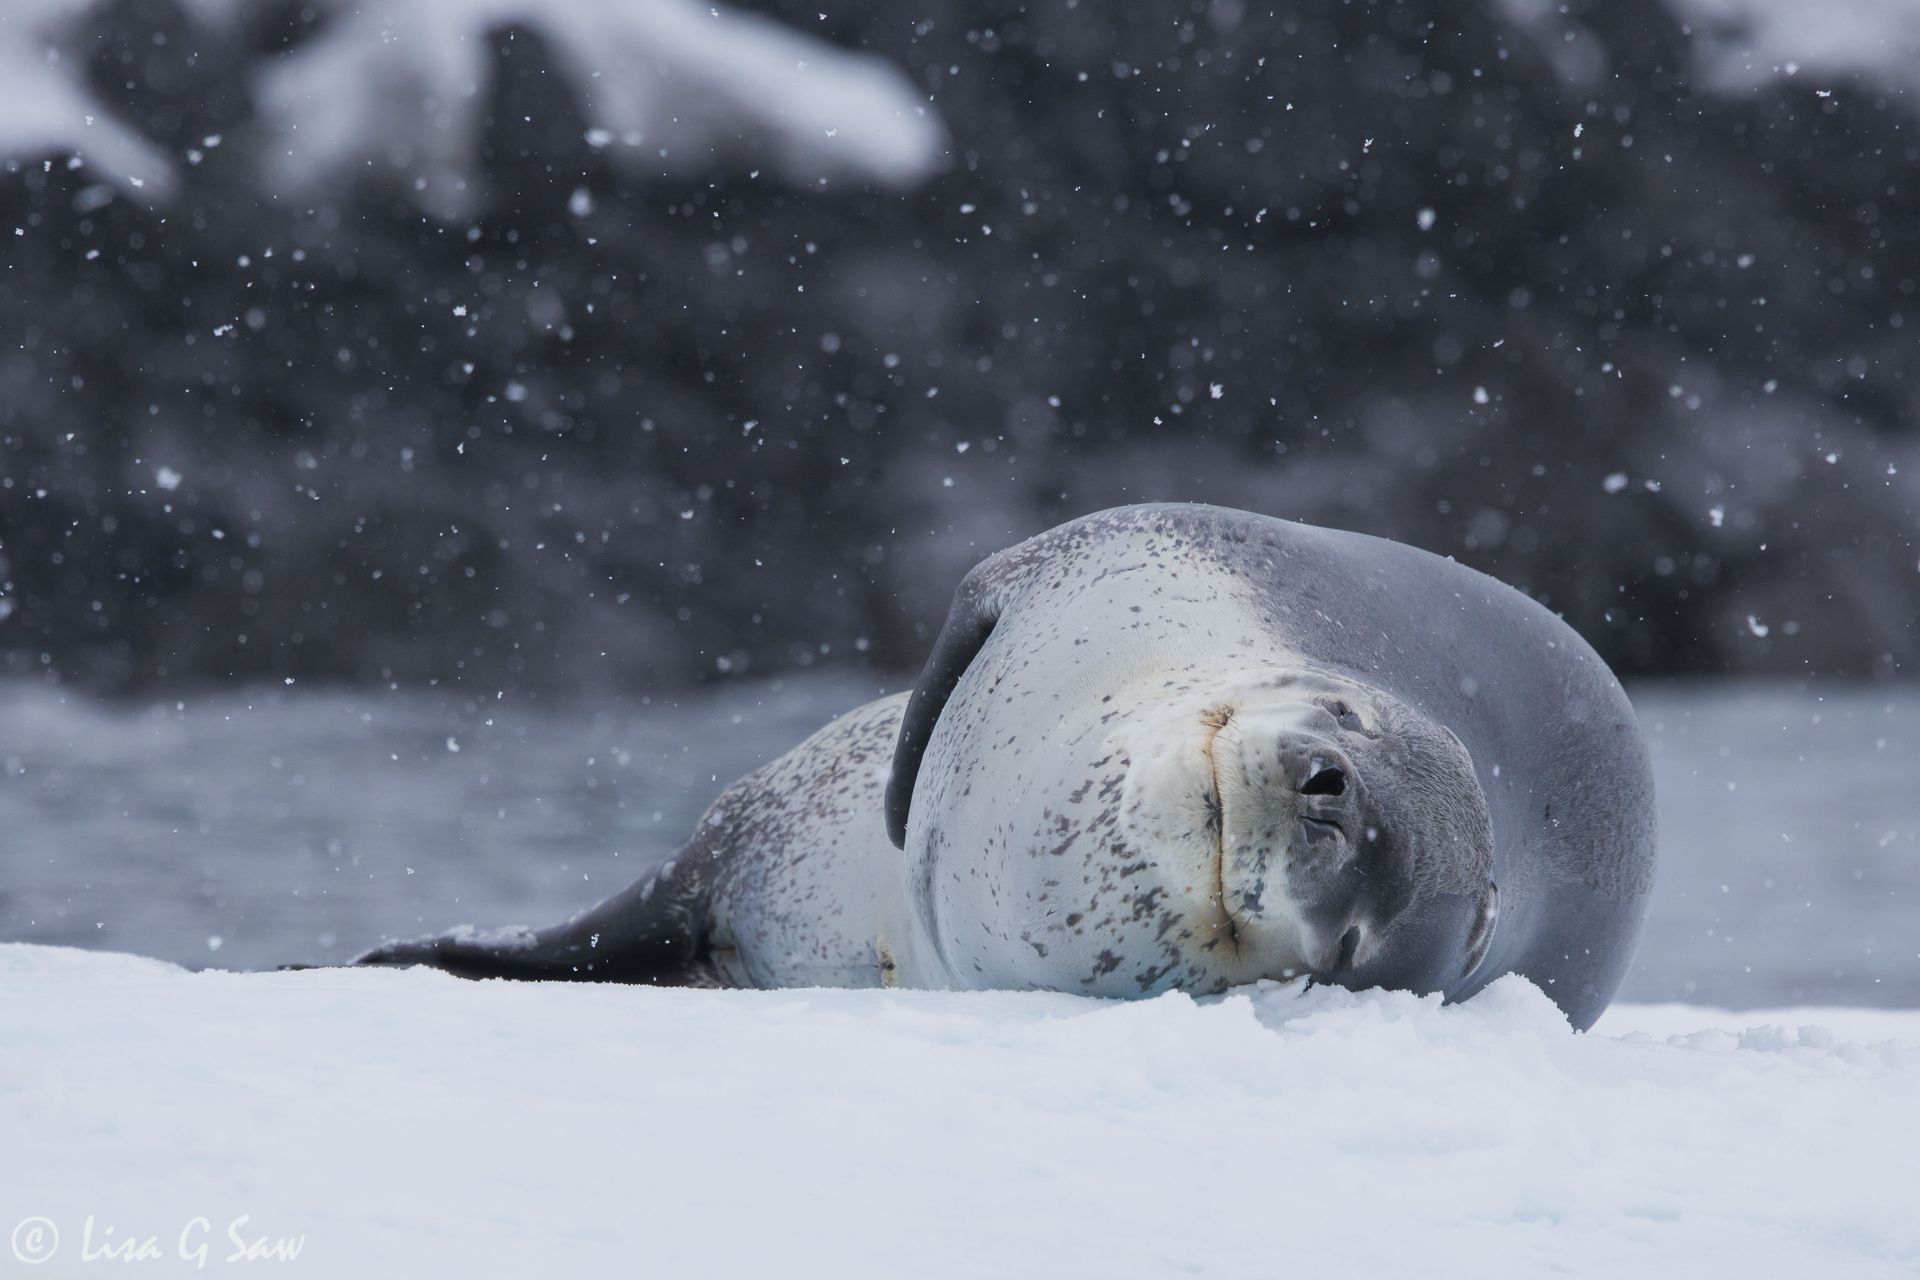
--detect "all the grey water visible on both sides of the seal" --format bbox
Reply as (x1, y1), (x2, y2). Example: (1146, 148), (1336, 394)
(0, 677), (1920, 1007)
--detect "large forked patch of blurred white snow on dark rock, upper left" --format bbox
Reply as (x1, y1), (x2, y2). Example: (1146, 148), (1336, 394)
(259, 0), (945, 217)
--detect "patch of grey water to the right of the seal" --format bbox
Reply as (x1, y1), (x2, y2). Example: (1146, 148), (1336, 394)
(1622, 683), (1920, 1007)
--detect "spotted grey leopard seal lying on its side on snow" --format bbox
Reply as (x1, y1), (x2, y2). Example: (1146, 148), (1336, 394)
(359, 505), (1655, 1029)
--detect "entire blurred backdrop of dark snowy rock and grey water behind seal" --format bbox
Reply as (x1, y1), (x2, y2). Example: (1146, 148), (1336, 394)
(0, 0), (1920, 1004)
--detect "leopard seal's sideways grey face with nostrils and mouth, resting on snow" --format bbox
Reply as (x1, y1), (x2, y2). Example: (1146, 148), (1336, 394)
(1119, 670), (1498, 990)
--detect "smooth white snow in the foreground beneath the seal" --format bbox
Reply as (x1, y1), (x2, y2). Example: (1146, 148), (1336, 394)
(0, 944), (1920, 1278)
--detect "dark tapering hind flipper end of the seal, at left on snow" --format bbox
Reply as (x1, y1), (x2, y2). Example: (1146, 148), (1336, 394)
(353, 850), (707, 986)
